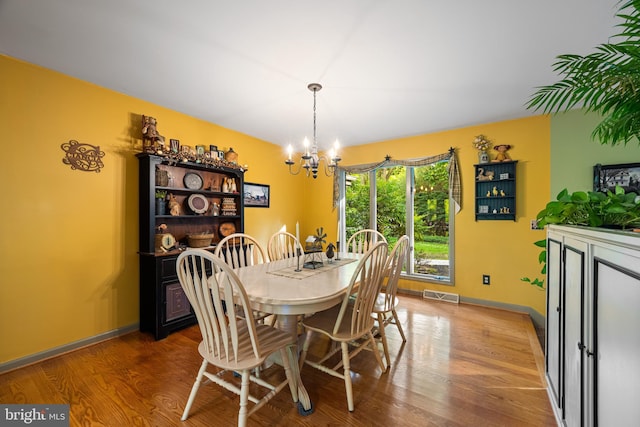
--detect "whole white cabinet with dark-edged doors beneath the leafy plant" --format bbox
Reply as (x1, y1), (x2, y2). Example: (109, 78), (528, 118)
(545, 226), (640, 427)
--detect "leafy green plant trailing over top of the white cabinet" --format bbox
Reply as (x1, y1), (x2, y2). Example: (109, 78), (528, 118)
(521, 186), (640, 288)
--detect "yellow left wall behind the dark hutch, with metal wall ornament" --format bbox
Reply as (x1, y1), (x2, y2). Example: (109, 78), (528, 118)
(0, 56), (304, 363)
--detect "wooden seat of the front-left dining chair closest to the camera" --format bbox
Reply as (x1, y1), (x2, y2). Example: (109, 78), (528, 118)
(198, 320), (293, 370)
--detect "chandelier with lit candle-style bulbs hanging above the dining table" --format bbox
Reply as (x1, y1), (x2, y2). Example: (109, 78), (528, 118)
(284, 83), (342, 179)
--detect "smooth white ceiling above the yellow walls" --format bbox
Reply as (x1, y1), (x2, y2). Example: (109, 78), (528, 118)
(0, 0), (619, 148)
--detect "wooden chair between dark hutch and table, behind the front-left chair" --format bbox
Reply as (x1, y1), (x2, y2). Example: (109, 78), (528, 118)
(213, 233), (276, 325)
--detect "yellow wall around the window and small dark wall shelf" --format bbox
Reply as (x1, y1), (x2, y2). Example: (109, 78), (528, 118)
(310, 116), (550, 315)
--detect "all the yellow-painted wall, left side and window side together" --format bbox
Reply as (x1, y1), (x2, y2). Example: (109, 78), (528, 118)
(0, 56), (549, 364)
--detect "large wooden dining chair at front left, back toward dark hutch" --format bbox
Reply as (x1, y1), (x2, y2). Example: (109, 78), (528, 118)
(177, 249), (298, 426)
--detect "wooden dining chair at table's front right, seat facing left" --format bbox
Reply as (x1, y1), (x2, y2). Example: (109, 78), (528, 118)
(300, 242), (388, 411)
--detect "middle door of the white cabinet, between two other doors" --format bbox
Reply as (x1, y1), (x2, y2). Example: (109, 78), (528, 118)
(561, 239), (588, 427)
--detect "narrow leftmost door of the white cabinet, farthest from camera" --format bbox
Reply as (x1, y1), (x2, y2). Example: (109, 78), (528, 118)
(545, 236), (563, 407)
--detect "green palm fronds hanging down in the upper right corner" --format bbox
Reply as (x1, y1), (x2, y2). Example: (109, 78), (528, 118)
(527, 0), (640, 146)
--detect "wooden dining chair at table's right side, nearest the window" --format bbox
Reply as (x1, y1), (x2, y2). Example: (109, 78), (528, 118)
(373, 235), (409, 367)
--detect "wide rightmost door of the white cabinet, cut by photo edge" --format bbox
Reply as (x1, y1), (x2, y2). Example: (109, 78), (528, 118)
(588, 247), (640, 427)
